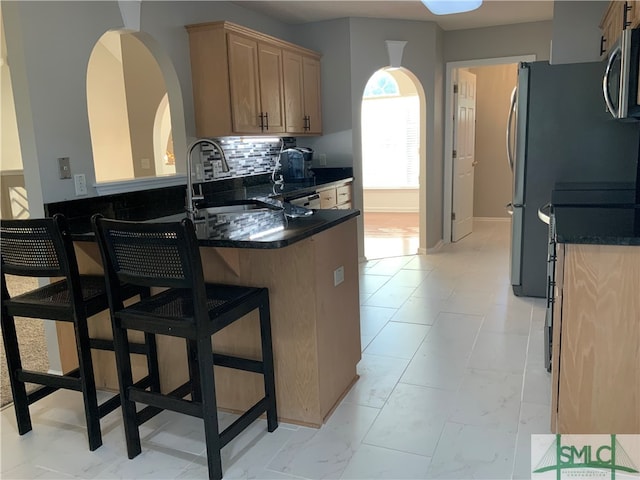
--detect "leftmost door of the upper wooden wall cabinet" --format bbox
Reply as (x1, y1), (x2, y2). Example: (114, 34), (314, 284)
(228, 33), (262, 133)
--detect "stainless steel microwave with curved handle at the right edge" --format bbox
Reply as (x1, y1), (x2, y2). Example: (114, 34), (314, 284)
(602, 28), (640, 119)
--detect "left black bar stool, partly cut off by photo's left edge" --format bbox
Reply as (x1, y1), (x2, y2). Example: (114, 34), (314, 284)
(0, 215), (160, 451)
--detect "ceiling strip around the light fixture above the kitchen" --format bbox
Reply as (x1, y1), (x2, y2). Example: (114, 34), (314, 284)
(233, 0), (553, 30)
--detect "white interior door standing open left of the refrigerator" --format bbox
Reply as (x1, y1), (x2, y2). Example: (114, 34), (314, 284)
(451, 69), (477, 242)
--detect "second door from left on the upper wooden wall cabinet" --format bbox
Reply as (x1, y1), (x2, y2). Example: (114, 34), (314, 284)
(258, 43), (285, 133)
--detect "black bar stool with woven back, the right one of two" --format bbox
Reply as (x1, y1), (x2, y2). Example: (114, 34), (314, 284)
(92, 215), (278, 479)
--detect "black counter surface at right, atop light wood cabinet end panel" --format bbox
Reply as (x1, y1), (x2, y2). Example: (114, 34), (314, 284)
(551, 183), (640, 246)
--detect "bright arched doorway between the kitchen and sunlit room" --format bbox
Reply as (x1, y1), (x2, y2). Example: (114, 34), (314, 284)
(361, 68), (425, 259)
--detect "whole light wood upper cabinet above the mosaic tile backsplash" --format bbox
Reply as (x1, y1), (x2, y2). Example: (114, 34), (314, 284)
(186, 22), (322, 137)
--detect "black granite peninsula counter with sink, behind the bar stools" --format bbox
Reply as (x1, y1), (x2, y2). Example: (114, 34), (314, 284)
(65, 169), (360, 249)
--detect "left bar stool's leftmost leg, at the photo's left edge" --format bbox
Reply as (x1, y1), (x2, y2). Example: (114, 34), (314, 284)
(1, 310), (32, 435)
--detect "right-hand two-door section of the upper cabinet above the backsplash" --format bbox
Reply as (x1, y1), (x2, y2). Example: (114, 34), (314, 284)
(284, 51), (322, 134)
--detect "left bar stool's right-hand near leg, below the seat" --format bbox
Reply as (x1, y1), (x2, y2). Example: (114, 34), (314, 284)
(74, 316), (102, 451)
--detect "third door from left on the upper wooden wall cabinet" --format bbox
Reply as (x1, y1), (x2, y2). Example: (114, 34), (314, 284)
(283, 51), (306, 133)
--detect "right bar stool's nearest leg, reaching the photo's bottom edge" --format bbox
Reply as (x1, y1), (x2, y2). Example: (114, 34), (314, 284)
(192, 337), (222, 480)
